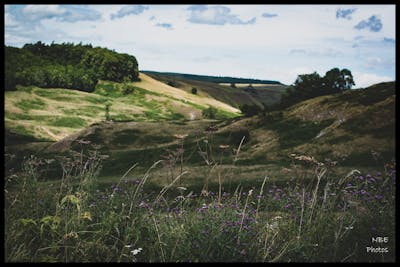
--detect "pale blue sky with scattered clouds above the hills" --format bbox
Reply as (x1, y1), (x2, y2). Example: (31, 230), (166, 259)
(4, 4), (396, 88)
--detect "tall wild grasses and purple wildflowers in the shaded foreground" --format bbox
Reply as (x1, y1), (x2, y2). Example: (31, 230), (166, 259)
(5, 139), (396, 262)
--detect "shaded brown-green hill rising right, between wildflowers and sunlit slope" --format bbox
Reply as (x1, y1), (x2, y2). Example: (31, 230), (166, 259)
(6, 81), (395, 183)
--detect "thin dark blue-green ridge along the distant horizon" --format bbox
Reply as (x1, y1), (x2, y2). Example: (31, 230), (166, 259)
(141, 70), (283, 85)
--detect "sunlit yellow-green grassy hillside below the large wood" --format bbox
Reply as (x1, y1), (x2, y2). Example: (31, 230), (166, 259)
(4, 75), (239, 144)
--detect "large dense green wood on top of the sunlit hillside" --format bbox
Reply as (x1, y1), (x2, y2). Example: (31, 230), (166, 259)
(4, 41), (139, 92)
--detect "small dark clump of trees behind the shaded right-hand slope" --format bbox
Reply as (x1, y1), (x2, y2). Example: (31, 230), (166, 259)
(280, 68), (355, 108)
